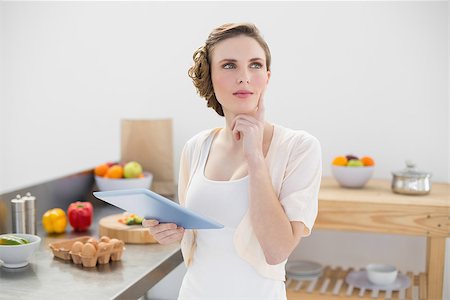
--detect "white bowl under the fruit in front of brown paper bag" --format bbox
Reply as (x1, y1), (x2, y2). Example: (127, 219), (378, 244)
(95, 172), (153, 191)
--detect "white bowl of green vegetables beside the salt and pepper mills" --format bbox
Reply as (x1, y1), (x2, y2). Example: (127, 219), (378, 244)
(0, 233), (41, 268)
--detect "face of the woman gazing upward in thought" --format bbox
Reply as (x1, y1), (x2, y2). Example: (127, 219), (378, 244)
(211, 35), (270, 116)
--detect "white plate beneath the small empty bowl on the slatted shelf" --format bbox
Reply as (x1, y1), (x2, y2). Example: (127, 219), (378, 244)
(345, 271), (411, 291)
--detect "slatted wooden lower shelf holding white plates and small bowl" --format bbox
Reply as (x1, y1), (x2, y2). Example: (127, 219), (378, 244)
(286, 267), (427, 300)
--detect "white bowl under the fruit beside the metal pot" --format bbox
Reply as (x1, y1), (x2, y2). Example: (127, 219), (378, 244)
(331, 165), (375, 188)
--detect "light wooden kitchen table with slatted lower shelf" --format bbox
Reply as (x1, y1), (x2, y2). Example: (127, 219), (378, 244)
(287, 177), (450, 300)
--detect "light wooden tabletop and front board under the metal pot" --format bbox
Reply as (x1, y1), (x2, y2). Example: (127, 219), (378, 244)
(315, 177), (450, 237)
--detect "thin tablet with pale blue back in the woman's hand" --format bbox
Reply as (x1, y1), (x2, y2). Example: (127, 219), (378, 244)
(93, 189), (223, 229)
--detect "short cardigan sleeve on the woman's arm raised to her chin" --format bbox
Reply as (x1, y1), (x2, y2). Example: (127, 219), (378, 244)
(280, 132), (322, 236)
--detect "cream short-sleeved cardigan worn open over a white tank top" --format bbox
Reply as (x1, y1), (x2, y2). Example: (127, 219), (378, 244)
(178, 125), (322, 280)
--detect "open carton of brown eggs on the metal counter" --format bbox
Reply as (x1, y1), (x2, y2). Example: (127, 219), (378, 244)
(49, 236), (125, 268)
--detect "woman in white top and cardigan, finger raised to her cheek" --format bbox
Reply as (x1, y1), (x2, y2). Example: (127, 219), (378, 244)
(144, 23), (322, 300)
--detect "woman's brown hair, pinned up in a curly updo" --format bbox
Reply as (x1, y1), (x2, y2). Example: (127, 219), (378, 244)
(188, 23), (271, 117)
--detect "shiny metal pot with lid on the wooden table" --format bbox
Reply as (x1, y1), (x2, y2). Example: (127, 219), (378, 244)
(391, 161), (431, 195)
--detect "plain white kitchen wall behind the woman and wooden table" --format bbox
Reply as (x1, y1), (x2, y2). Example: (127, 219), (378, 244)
(0, 1), (450, 295)
